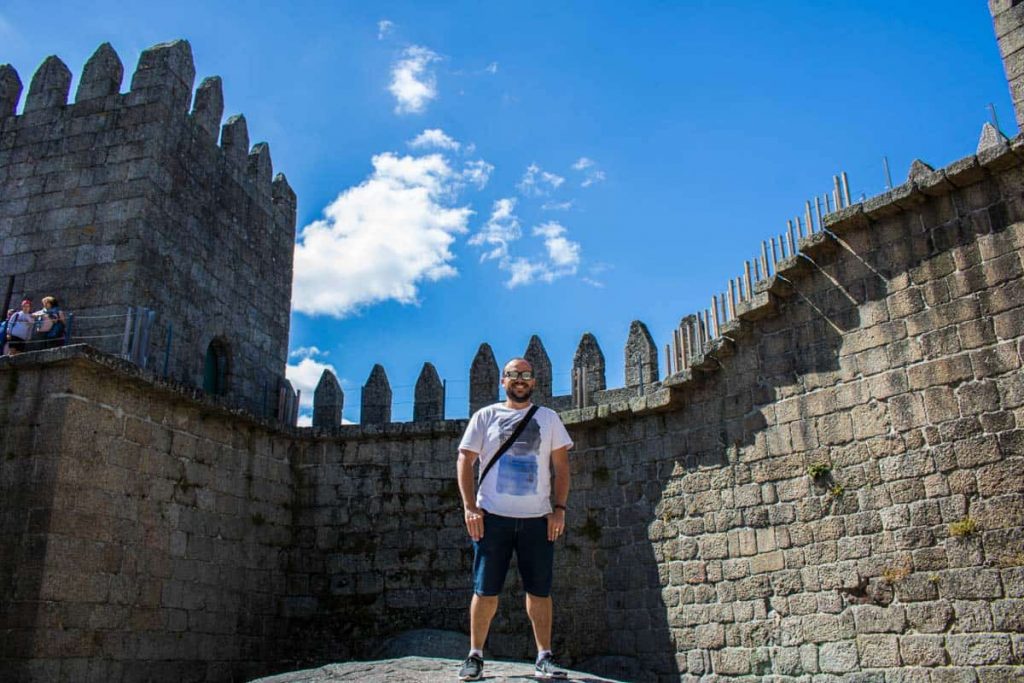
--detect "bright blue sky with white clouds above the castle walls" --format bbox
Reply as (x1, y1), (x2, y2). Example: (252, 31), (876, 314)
(0, 0), (1017, 421)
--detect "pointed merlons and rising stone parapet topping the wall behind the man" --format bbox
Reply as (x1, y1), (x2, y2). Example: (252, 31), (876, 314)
(314, 123), (1024, 428)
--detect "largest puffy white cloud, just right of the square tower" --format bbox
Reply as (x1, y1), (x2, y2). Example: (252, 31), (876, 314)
(292, 153), (473, 317)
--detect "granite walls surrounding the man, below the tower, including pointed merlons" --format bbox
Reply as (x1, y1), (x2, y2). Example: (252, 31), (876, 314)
(0, 5), (1024, 683)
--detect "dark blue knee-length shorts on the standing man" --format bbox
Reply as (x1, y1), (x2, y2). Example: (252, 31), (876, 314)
(473, 511), (555, 598)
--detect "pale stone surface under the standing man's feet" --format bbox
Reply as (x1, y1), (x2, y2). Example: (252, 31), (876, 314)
(252, 656), (616, 683)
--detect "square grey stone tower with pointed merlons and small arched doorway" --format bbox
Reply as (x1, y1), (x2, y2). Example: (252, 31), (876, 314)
(0, 40), (296, 417)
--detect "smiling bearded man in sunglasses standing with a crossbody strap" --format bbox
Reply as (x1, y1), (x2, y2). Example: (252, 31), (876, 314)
(458, 358), (572, 681)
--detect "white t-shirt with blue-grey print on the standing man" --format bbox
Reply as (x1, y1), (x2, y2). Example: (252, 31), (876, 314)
(459, 403), (572, 517)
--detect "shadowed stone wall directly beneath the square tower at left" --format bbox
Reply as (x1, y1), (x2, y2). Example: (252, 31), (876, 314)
(0, 347), (294, 681)
